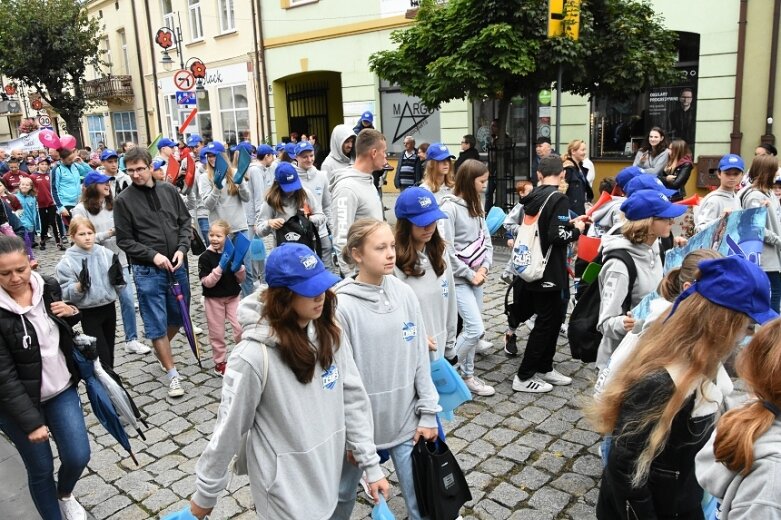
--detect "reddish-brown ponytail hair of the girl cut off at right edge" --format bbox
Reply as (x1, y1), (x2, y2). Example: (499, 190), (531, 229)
(713, 319), (781, 476)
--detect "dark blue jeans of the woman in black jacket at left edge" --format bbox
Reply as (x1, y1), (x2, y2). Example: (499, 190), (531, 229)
(0, 385), (90, 520)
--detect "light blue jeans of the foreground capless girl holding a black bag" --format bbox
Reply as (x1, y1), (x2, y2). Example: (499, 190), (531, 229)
(331, 439), (422, 520)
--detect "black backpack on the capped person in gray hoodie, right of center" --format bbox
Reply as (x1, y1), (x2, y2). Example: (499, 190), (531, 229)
(567, 249), (637, 363)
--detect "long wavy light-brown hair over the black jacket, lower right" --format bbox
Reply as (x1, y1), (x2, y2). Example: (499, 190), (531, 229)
(586, 288), (750, 486)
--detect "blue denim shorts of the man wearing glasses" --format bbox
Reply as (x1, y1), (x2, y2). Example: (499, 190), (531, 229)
(133, 262), (190, 340)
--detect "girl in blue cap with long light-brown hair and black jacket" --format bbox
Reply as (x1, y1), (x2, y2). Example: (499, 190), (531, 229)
(590, 256), (778, 519)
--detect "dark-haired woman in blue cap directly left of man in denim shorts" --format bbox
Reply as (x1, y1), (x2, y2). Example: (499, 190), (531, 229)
(72, 171), (151, 354)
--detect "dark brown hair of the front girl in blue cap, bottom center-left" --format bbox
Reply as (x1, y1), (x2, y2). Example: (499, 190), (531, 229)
(260, 287), (341, 384)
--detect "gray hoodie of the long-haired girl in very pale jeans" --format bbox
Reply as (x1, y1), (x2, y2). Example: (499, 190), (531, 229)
(439, 193), (494, 285)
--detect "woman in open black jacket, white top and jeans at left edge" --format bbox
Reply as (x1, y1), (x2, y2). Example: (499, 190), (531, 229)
(0, 236), (90, 520)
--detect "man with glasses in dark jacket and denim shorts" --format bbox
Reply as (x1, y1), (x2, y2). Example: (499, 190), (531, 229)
(114, 147), (192, 397)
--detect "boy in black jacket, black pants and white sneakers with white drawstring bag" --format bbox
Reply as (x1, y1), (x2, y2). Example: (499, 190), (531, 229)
(505, 157), (585, 393)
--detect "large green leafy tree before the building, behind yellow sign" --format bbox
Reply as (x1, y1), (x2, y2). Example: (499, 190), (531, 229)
(369, 0), (679, 134)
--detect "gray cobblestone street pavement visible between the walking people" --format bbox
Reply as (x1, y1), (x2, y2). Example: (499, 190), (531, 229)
(21, 241), (601, 520)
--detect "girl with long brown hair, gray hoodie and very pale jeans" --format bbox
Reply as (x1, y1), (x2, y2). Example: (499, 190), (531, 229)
(442, 159), (496, 396)
